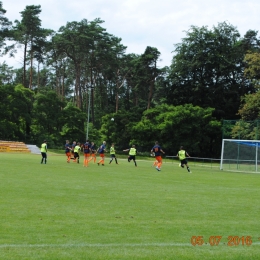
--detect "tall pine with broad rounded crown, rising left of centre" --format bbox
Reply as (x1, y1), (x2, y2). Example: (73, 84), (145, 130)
(52, 19), (125, 126)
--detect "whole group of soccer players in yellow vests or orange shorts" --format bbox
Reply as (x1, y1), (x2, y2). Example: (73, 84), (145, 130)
(41, 140), (191, 172)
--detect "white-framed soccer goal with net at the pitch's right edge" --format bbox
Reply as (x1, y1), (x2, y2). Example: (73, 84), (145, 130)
(220, 139), (260, 172)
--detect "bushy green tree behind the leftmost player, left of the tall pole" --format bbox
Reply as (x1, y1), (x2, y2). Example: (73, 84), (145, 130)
(31, 89), (86, 146)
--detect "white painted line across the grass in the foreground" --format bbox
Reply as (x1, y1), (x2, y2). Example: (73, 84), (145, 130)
(0, 242), (260, 248)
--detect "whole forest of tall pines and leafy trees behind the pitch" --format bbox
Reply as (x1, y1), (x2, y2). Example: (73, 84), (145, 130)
(0, 2), (260, 158)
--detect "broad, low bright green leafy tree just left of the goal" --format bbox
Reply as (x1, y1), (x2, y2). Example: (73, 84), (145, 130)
(131, 104), (221, 157)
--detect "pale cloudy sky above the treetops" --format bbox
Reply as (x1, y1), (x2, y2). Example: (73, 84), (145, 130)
(0, 0), (260, 67)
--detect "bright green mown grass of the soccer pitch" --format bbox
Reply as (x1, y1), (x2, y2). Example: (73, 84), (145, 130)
(0, 153), (260, 260)
